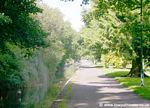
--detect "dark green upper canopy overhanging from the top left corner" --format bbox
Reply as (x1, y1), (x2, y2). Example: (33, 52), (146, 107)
(0, 0), (44, 51)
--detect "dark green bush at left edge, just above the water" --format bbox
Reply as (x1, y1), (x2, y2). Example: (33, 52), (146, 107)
(0, 54), (23, 90)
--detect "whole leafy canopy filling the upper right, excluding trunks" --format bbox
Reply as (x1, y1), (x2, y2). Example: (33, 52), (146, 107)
(83, 0), (150, 72)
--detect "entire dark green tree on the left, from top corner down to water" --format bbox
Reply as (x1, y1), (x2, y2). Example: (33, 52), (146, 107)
(0, 0), (47, 91)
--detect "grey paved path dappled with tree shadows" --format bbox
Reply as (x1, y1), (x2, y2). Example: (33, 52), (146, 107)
(67, 61), (150, 108)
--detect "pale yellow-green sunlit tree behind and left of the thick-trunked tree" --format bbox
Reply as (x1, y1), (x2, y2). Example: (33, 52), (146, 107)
(81, 8), (131, 67)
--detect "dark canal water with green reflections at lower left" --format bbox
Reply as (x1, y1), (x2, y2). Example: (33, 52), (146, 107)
(0, 85), (47, 108)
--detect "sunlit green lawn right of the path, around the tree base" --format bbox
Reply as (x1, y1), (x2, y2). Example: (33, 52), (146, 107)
(106, 71), (150, 100)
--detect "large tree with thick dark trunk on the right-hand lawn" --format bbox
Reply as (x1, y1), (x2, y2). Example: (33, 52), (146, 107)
(82, 0), (150, 76)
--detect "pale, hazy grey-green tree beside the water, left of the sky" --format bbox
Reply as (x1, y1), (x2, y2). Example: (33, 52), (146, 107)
(34, 4), (79, 79)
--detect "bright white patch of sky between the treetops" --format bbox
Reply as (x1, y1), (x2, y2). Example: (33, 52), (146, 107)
(43, 0), (87, 31)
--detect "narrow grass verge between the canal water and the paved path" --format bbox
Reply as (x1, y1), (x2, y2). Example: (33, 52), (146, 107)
(33, 64), (78, 108)
